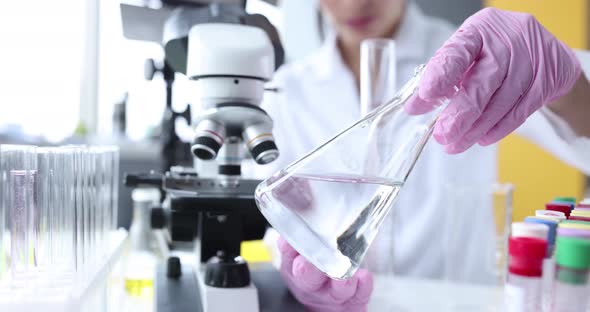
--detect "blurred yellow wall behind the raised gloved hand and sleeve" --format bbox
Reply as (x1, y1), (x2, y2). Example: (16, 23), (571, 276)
(485, 0), (589, 221)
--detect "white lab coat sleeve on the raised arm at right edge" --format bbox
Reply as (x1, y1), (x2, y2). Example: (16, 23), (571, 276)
(517, 51), (590, 175)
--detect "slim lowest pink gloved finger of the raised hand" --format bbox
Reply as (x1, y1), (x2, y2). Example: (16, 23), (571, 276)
(444, 60), (533, 154)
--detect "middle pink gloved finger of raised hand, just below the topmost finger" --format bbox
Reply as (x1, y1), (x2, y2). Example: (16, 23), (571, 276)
(433, 53), (508, 145)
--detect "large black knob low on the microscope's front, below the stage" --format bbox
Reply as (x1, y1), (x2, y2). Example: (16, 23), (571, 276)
(205, 251), (250, 288)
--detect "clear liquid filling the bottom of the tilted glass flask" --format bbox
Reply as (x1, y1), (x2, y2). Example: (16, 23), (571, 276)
(256, 174), (402, 279)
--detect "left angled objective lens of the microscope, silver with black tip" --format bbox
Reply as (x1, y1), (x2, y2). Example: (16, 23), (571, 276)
(191, 119), (225, 160)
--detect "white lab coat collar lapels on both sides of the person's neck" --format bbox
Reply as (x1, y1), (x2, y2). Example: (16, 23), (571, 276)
(313, 1), (428, 80)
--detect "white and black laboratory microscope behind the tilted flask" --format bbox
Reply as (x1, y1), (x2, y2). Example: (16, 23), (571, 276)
(121, 0), (302, 312)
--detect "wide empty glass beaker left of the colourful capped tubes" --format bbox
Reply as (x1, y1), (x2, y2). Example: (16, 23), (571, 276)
(442, 183), (514, 286)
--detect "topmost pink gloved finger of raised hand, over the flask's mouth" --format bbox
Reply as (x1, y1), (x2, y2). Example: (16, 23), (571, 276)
(418, 21), (483, 101)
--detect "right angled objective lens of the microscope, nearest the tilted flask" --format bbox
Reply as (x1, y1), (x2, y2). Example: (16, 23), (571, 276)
(243, 124), (279, 165)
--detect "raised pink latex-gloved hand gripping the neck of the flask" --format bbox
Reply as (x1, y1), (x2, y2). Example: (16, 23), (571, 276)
(408, 8), (581, 154)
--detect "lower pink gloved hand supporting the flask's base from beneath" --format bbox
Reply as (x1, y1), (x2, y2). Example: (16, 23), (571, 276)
(278, 237), (373, 312)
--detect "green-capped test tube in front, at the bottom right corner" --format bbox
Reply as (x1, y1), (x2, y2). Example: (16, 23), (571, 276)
(550, 236), (590, 312)
